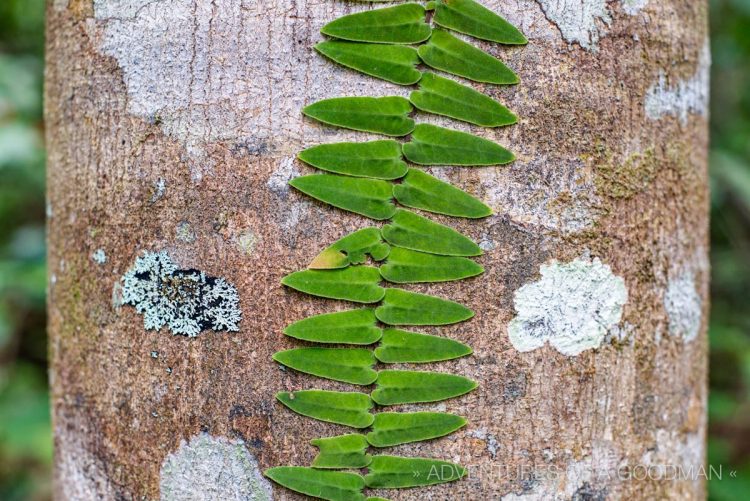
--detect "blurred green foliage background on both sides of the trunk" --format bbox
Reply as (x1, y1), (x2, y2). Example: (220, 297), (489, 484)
(0, 0), (750, 501)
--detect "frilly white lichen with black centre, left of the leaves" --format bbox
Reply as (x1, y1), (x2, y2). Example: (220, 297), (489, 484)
(121, 251), (242, 337)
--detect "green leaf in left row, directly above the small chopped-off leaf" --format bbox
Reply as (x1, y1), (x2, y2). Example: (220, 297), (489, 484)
(276, 390), (375, 428)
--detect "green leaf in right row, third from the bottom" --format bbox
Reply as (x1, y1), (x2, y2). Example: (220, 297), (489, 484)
(370, 370), (477, 405)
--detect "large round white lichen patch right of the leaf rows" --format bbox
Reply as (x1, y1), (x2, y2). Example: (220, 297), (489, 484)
(508, 258), (628, 356)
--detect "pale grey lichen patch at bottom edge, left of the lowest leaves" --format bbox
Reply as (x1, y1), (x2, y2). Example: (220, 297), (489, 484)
(159, 433), (273, 501)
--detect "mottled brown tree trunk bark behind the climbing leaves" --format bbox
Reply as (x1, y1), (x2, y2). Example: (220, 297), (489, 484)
(46, 0), (709, 500)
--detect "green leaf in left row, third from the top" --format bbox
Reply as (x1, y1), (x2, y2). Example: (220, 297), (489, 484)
(302, 96), (414, 136)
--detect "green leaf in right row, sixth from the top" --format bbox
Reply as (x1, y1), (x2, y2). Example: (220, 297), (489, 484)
(380, 209), (482, 256)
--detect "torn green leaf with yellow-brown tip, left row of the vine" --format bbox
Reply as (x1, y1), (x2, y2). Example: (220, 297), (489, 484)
(308, 228), (391, 270)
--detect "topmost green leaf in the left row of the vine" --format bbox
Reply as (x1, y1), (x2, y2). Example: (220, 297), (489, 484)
(320, 3), (431, 44)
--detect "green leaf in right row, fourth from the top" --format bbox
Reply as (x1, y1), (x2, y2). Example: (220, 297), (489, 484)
(406, 124), (516, 166)
